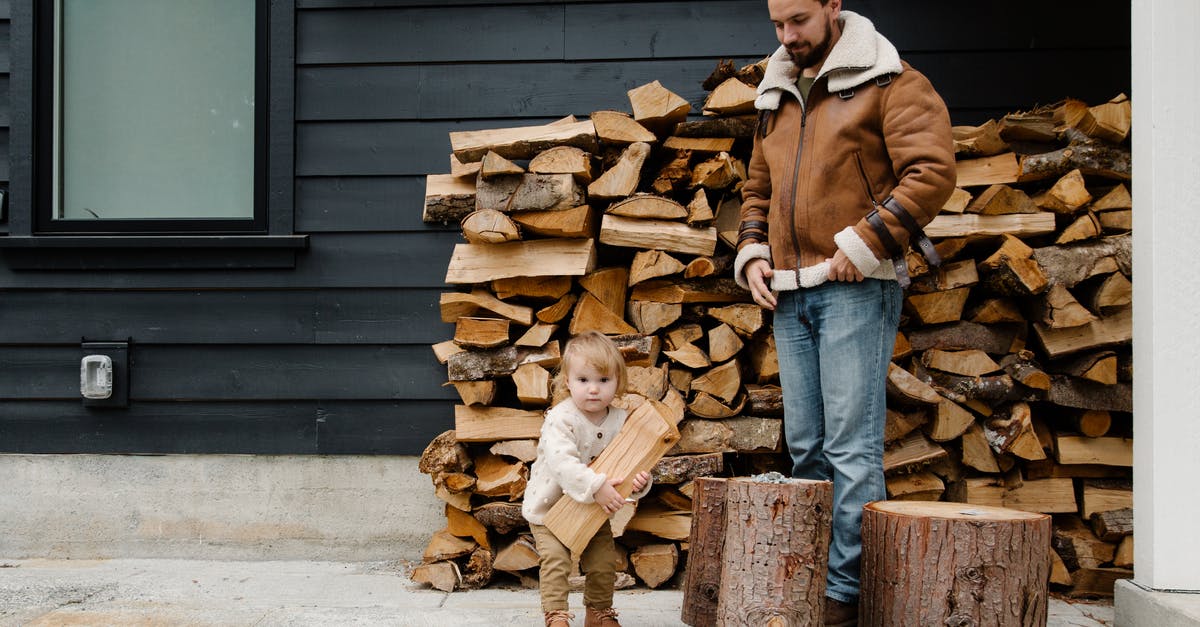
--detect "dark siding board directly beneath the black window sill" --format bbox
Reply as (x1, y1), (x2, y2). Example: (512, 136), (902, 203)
(0, 231), (462, 289)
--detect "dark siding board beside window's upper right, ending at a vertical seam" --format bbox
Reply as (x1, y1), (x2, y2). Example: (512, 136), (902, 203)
(296, 5), (563, 65)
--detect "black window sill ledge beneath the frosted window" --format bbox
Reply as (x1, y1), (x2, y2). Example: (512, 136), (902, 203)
(0, 235), (308, 265)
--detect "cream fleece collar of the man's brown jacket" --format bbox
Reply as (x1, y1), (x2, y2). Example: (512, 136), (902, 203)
(755, 11), (904, 109)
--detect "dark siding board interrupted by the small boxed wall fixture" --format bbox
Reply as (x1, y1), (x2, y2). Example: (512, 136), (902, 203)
(0, 344), (456, 404)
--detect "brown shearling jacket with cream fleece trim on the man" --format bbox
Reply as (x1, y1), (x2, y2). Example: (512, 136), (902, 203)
(734, 11), (955, 289)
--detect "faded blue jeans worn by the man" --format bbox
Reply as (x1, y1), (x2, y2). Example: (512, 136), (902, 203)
(774, 279), (902, 603)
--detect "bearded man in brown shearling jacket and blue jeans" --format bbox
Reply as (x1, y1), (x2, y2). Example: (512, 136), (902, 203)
(734, 0), (955, 625)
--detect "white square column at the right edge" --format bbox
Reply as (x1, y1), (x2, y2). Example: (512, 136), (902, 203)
(1132, 0), (1200, 591)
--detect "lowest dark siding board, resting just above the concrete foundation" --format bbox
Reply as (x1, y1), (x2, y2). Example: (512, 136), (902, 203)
(0, 401), (454, 455)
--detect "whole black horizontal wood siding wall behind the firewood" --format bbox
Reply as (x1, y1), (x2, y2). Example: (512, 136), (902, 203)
(0, 0), (1130, 454)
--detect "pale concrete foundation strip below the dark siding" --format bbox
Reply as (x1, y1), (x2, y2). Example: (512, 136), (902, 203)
(0, 455), (445, 561)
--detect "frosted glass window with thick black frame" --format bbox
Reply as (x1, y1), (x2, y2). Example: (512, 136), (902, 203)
(0, 0), (307, 269)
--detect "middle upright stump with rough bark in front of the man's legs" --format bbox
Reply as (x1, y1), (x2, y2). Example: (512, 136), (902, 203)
(716, 477), (833, 627)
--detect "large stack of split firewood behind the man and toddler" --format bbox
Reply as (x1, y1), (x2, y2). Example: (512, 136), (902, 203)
(413, 62), (1132, 593)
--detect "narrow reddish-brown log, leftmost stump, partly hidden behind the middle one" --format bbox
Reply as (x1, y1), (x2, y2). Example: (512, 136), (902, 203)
(680, 477), (726, 627)
